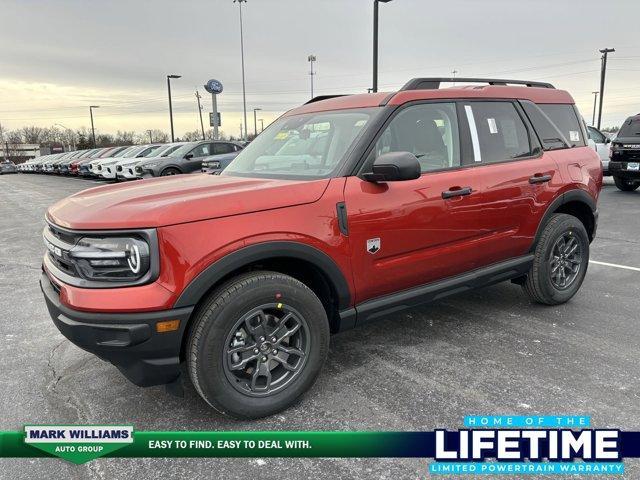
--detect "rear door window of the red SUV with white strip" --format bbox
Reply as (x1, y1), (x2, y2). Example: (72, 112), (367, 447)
(464, 102), (535, 163)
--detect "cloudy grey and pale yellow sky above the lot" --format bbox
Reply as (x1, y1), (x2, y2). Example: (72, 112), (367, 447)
(0, 0), (640, 135)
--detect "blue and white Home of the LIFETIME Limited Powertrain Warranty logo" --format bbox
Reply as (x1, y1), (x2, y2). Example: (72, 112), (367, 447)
(429, 416), (624, 475)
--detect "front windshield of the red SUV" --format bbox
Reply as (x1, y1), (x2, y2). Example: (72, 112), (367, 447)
(223, 108), (379, 179)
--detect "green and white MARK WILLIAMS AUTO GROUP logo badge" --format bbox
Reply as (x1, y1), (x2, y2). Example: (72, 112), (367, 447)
(24, 425), (133, 464)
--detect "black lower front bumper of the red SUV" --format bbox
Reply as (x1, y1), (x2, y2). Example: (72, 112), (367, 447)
(40, 273), (193, 387)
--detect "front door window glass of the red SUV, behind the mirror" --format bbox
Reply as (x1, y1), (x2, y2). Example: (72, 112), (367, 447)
(374, 103), (460, 172)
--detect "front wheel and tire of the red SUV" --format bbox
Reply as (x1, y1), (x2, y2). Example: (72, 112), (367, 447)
(186, 271), (329, 419)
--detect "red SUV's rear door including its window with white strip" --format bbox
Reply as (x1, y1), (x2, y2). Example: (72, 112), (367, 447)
(462, 100), (562, 266)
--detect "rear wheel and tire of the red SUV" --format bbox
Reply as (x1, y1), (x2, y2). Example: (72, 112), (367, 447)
(522, 213), (589, 305)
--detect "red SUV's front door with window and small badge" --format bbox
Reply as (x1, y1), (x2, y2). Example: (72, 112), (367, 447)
(344, 102), (484, 303)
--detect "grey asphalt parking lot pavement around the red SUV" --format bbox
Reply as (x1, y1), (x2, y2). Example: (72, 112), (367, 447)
(0, 175), (640, 479)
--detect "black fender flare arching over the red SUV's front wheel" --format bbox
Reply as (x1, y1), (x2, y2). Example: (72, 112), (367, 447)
(174, 242), (351, 310)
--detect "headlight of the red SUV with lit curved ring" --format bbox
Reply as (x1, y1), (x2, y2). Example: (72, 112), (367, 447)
(69, 237), (151, 282)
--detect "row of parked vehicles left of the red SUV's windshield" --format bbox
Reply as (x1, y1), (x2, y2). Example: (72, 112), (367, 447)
(17, 140), (243, 180)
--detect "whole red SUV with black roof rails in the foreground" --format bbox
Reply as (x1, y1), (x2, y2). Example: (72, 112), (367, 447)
(41, 78), (602, 418)
